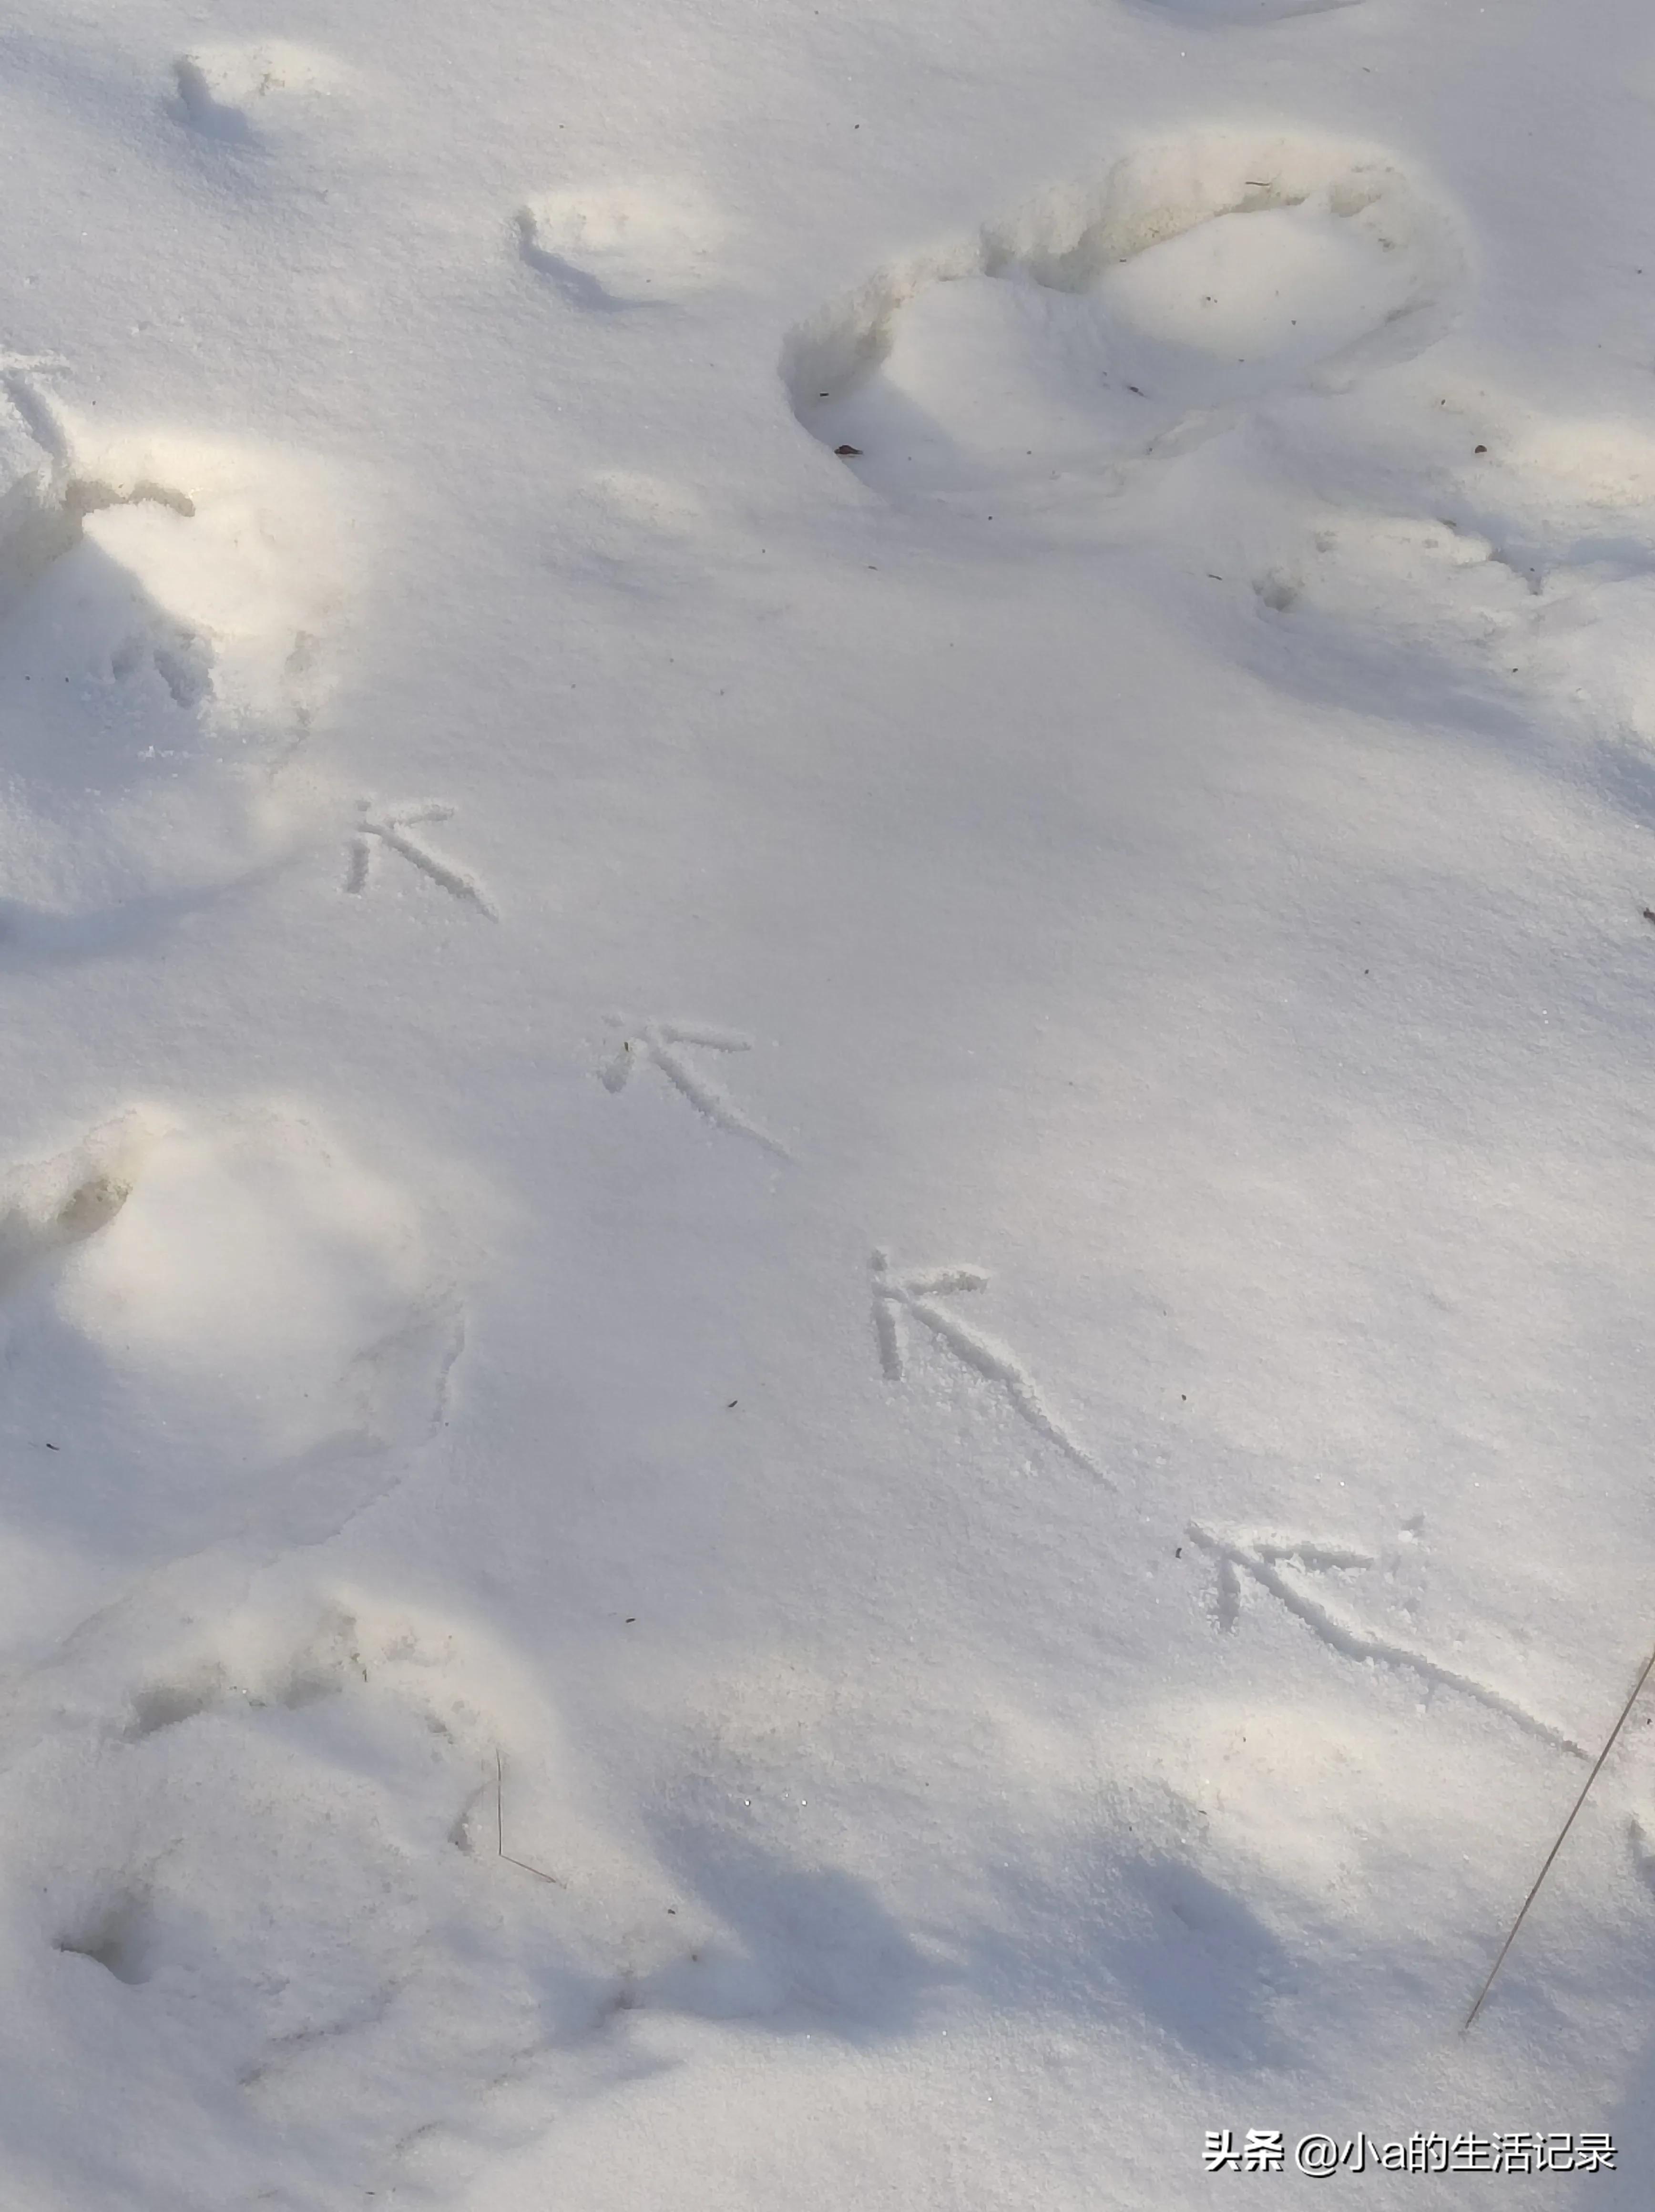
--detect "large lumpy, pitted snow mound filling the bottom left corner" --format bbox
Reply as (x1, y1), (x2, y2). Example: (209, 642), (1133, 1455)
(0, 1593), (617, 2208)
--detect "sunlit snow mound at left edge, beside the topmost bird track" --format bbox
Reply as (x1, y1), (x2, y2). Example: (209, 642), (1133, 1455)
(0, 369), (352, 933)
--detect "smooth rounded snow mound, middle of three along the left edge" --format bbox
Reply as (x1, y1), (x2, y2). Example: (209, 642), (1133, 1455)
(0, 1108), (460, 1601)
